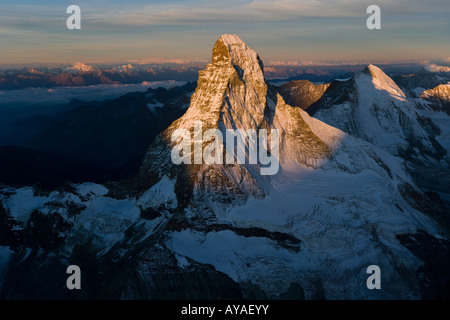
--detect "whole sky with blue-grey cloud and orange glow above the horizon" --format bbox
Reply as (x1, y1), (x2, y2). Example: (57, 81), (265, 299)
(0, 0), (450, 64)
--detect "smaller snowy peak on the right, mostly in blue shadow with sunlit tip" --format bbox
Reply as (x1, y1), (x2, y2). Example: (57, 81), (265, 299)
(308, 65), (445, 163)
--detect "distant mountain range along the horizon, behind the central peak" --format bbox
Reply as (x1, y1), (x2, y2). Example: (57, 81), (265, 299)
(0, 62), (449, 90)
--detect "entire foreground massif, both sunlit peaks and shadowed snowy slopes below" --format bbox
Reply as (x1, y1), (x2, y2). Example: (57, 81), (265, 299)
(0, 35), (449, 299)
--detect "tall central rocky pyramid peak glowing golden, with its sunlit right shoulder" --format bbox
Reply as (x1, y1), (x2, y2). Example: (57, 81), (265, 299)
(141, 35), (343, 203)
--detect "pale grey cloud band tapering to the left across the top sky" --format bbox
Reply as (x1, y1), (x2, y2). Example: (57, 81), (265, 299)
(86, 0), (450, 26)
